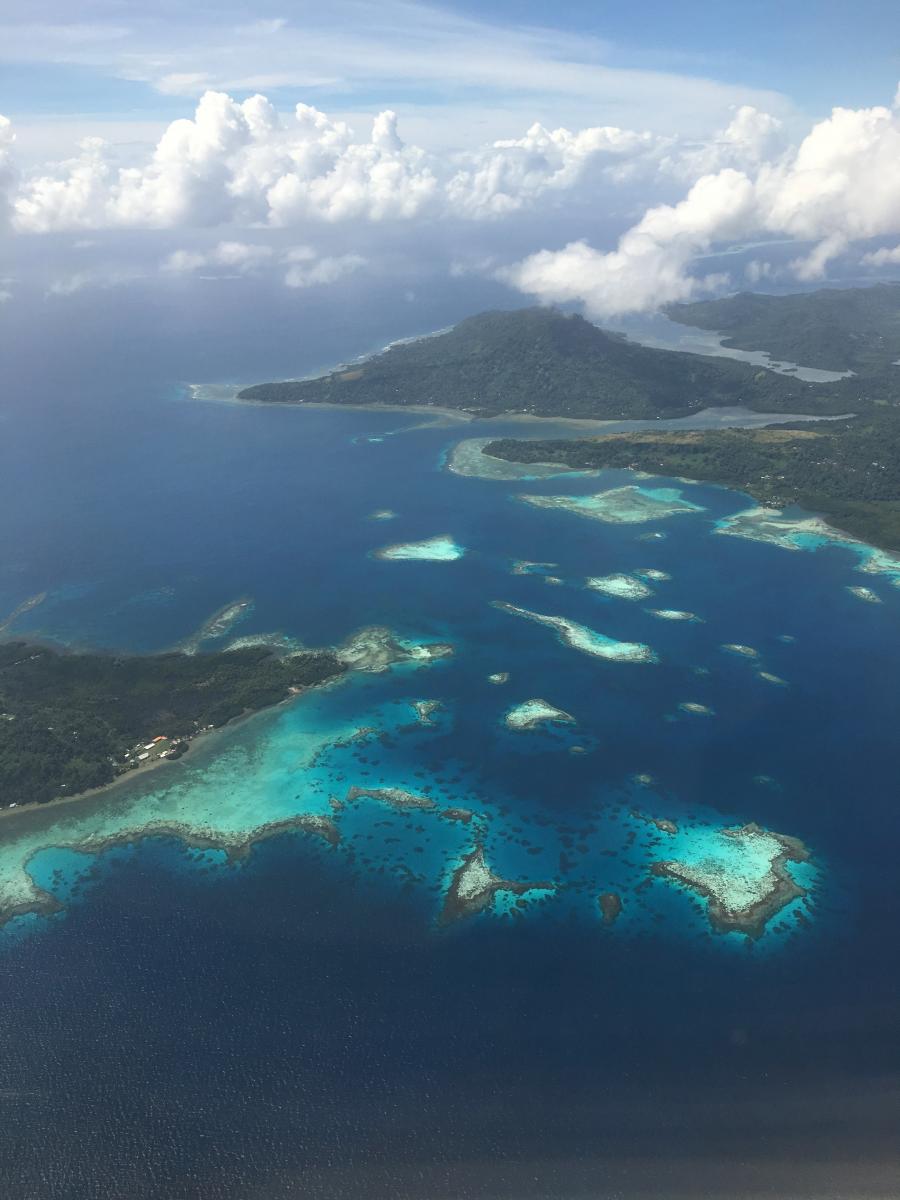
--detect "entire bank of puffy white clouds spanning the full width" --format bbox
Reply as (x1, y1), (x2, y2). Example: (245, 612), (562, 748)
(0, 81), (900, 318)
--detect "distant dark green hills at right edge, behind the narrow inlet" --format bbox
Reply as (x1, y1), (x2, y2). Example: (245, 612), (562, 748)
(666, 283), (900, 374)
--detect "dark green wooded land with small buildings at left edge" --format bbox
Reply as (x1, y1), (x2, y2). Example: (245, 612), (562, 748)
(0, 641), (347, 806)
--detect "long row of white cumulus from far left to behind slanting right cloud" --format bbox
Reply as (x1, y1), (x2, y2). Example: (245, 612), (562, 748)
(0, 91), (779, 233)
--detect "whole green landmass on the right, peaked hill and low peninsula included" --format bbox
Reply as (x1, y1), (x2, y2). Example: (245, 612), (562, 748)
(240, 284), (900, 551)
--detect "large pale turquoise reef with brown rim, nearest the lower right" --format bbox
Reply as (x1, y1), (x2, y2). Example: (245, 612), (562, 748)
(650, 823), (810, 938)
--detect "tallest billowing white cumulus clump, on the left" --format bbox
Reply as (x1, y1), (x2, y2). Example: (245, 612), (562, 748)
(14, 91), (436, 233)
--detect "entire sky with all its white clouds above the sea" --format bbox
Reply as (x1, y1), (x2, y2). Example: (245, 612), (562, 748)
(0, 0), (900, 332)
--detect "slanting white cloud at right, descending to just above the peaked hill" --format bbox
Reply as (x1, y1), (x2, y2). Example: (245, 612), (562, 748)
(506, 89), (900, 317)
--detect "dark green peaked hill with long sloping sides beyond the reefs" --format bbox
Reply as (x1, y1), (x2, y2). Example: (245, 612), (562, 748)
(239, 308), (858, 419)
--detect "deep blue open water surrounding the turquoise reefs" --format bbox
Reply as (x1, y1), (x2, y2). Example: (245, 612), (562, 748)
(0, 324), (900, 1200)
